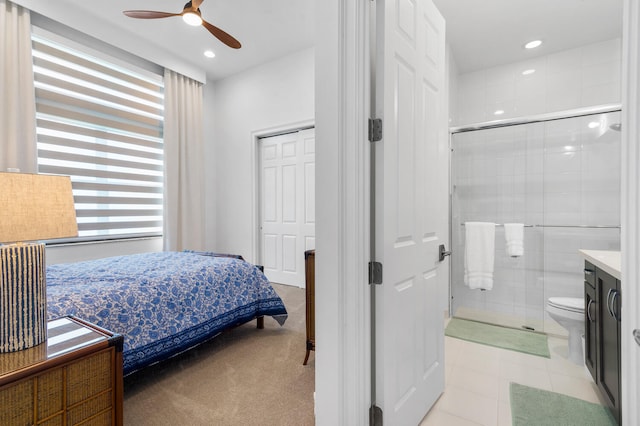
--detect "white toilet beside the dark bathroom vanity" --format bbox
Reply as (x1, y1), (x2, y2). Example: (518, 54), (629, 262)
(547, 297), (584, 365)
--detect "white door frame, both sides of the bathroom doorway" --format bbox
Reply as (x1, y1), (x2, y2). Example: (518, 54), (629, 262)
(315, 0), (640, 425)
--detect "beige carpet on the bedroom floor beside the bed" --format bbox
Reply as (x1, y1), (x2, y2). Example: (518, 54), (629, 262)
(124, 284), (315, 426)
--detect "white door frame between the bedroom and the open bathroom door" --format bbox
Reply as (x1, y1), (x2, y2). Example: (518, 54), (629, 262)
(315, 0), (375, 425)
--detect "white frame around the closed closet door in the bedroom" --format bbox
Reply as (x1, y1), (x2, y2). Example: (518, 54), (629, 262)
(251, 119), (315, 265)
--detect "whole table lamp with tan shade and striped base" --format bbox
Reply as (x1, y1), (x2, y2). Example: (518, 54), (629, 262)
(0, 172), (78, 353)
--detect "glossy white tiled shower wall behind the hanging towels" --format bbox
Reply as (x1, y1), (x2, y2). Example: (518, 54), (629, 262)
(452, 40), (620, 332)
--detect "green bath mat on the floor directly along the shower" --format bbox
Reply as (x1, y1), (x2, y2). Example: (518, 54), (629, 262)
(444, 318), (550, 358)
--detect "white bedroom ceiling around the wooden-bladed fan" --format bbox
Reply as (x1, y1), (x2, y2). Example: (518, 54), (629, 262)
(56, 0), (315, 80)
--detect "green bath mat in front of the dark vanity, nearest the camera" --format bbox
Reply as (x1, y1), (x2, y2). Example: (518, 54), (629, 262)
(509, 383), (616, 426)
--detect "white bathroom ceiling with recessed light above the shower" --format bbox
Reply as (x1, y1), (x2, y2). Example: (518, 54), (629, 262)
(434, 0), (622, 73)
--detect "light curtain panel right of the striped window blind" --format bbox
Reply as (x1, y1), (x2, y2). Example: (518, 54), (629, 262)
(164, 70), (204, 250)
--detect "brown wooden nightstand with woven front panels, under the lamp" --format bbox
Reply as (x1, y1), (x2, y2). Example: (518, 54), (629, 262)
(0, 317), (123, 426)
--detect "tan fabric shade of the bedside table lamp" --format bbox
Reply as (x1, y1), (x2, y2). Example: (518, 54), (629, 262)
(0, 173), (78, 243)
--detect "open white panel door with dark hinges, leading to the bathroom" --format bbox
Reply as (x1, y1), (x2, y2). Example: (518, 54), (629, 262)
(374, 0), (448, 426)
